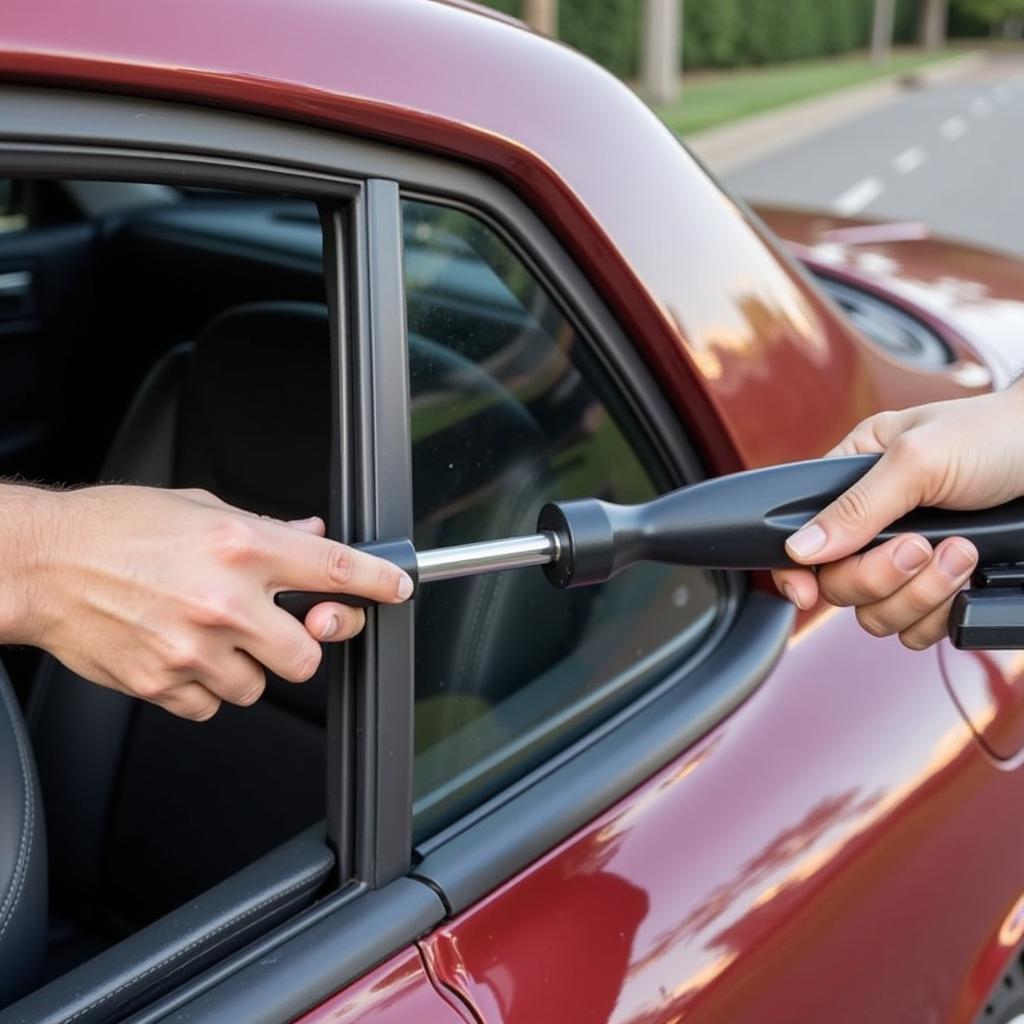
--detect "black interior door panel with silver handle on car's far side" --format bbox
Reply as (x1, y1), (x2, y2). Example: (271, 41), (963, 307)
(0, 222), (95, 476)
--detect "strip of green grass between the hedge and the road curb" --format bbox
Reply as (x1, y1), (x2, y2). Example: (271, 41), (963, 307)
(655, 49), (961, 135)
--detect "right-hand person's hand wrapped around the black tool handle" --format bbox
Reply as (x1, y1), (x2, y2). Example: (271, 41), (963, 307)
(772, 385), (1024, 650)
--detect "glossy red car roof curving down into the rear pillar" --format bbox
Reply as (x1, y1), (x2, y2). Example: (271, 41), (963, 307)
(0, 0), (987, 470)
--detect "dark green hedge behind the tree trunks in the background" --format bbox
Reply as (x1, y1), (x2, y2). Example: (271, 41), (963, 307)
(486, 0), (919, 78)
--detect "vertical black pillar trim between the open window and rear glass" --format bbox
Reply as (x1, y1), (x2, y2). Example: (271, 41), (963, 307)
(353, 178), (414, 888)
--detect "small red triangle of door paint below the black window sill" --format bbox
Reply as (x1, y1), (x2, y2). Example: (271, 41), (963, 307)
(295, 949), (473, 1024)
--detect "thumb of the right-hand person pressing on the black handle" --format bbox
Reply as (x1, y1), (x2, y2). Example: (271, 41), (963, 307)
(785, 452), (921, 565)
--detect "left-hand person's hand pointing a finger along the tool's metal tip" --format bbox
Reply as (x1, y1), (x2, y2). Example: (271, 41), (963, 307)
(0, 485), (412, 720)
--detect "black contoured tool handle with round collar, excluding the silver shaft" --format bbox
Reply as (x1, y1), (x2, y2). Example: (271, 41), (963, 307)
(538, 455), (1024, 587)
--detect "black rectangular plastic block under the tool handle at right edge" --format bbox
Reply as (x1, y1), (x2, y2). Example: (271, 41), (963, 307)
(949, 563), (1024, 650)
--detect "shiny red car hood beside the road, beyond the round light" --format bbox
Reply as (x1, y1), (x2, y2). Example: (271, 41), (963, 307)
(755, 206), (1024, 387)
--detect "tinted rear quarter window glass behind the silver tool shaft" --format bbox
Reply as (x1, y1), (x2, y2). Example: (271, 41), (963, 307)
(403, 201), (718, 837)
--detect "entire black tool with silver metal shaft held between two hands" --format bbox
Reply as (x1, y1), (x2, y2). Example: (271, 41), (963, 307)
(276, 455), (1024, 649)
